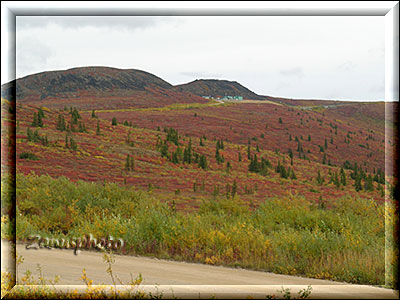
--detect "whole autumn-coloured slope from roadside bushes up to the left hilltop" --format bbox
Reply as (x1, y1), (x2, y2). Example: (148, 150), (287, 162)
(2, 68), (395, 284)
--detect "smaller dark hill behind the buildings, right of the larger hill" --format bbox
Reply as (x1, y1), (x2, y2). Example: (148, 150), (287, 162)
(174, 79), (265, 100)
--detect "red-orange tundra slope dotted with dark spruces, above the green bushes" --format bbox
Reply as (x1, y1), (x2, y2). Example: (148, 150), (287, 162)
(8, 100), (391, 210)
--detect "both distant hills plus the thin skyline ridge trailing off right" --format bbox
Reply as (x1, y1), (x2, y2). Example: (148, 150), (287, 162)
(1, 67), (368, 109)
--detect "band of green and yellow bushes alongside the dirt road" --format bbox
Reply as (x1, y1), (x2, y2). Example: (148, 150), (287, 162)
(2, 174), (393, 287)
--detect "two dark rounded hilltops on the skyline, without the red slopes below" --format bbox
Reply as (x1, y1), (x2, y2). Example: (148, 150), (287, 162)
(2, 66), (265, 102)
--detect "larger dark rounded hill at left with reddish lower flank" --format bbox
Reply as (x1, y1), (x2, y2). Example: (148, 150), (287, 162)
(2, 67), (206, 109)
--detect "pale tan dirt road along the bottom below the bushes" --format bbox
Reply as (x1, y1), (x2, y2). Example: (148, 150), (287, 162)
(2, 244), (398, 299)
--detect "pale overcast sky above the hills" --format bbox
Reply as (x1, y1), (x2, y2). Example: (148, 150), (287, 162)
(16, 16), (385, 100)
